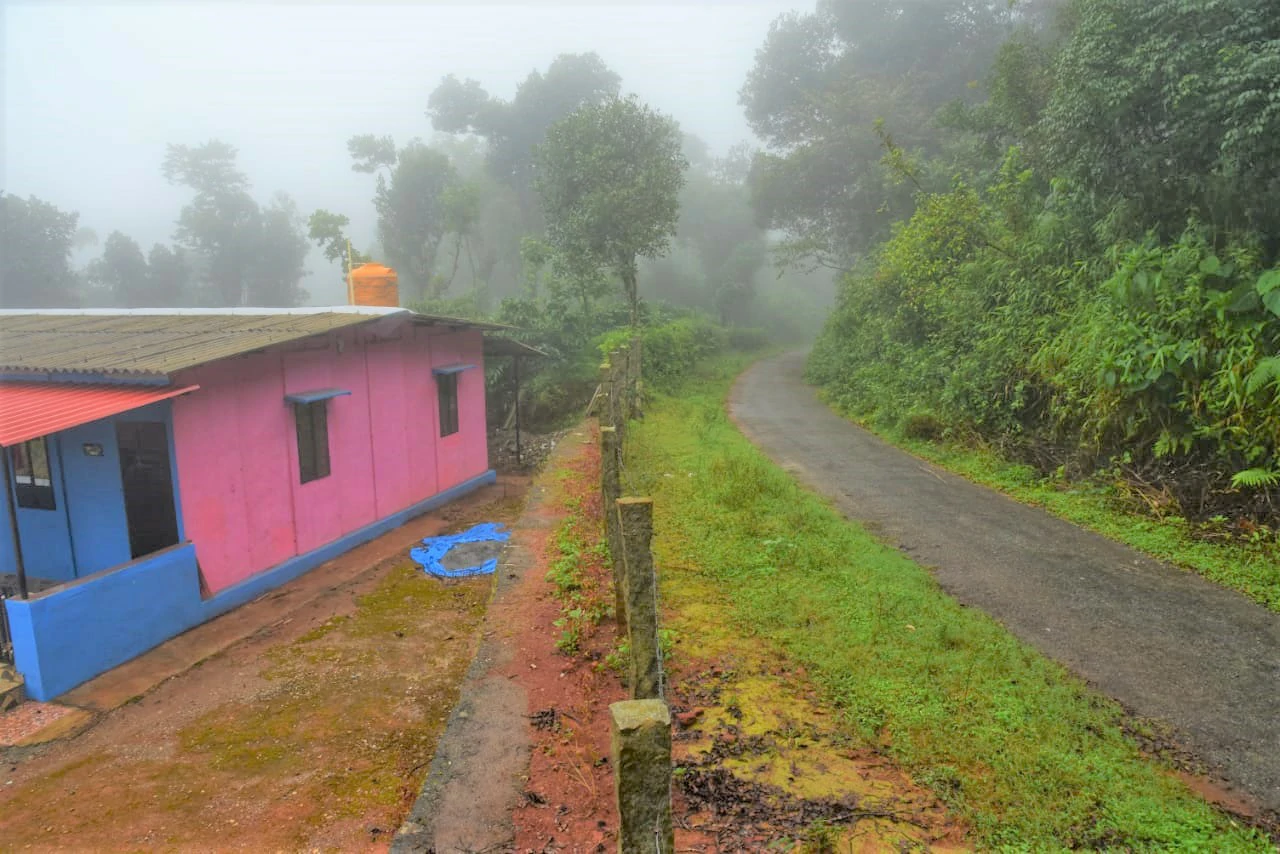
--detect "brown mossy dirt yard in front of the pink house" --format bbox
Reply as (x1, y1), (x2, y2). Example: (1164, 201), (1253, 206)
(0, 478), (527, 851)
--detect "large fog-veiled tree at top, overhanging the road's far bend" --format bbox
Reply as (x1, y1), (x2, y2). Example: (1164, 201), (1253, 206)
(740, 0), (1023, 268)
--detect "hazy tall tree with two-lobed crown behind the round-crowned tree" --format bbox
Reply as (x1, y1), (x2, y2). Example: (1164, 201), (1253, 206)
(426, 54), (621, 214)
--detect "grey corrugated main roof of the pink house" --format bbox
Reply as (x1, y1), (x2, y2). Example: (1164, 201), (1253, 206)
(0, 307), (497, 379)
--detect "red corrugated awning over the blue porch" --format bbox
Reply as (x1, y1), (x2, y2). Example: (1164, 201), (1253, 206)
(0, 383), (200, 448)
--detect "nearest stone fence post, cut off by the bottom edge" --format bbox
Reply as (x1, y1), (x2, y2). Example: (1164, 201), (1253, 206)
(609, 700), (676, 854)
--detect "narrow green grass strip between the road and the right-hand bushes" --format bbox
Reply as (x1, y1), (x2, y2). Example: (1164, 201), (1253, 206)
(864, 435), (1280, 612)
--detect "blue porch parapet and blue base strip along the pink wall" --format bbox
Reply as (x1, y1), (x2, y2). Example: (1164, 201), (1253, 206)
(5, 470), (497, 700)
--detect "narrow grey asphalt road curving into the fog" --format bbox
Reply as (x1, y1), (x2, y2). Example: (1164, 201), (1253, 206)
(730, 353), (1280, 810)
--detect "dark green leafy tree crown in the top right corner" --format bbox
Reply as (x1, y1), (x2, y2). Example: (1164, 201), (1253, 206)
(1036, 0), (1280, 257)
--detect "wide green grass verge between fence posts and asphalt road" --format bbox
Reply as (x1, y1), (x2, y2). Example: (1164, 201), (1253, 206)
(627, 362), (1271, 851)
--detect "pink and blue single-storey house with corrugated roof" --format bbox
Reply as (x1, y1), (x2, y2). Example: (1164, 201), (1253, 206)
(0, 306), (513, 699)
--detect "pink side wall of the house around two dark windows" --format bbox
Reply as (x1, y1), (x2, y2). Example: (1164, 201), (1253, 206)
(173, 321), (489, 592)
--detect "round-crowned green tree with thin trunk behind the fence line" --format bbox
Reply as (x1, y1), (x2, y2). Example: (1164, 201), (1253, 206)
(535, 96), (689, 325)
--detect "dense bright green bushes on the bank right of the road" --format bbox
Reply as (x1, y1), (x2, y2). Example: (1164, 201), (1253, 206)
(809, 186), (1280, 519)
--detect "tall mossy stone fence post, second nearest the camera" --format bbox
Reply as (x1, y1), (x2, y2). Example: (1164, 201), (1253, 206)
(616, 498), (662, 700)
